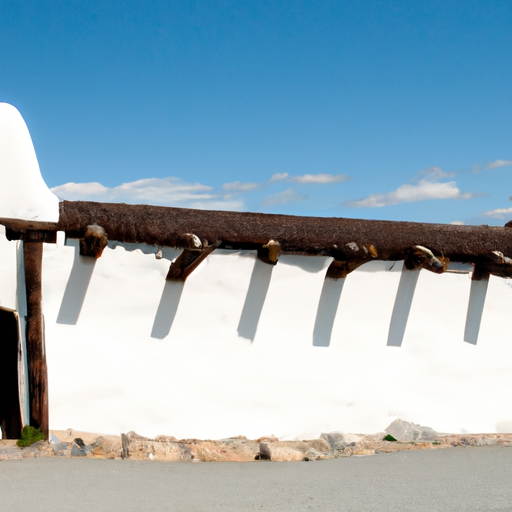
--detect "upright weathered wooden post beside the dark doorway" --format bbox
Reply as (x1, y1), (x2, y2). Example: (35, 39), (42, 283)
(23, 241), (48, 439)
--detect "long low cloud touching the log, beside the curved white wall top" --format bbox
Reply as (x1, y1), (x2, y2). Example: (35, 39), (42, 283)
(52, 177), (243, 210)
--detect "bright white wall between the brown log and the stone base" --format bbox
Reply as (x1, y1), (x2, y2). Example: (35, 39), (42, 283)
(37, 241), (512, 438)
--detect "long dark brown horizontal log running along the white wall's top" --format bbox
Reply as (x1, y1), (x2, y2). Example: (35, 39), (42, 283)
(0, 201), (512, 263)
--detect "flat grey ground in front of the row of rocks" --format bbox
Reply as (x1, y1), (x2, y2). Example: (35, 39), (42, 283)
(0, 446), (512, 512)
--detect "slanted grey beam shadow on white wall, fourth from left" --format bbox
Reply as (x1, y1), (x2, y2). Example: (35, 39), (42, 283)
(313, 277), (346, 347)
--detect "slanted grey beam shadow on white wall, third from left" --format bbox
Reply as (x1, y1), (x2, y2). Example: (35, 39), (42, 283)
(237, 259), (274, 341)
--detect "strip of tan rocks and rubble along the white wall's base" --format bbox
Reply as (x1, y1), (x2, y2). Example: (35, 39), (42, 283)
(0, 420), (512, 462)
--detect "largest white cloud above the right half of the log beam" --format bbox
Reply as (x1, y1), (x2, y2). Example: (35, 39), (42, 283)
(345, 179), (474, 208)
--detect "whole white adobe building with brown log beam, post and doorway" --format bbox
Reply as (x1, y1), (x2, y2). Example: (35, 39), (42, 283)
(0, 103), (512, 439)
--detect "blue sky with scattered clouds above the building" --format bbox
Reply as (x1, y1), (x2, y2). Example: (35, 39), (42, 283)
(0, 0), (512, 225)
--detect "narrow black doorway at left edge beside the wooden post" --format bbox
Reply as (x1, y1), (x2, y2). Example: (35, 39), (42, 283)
(0, 308), (21, 439)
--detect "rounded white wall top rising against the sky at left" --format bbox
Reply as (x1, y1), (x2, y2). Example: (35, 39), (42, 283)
(0, 103), (59, 222)
